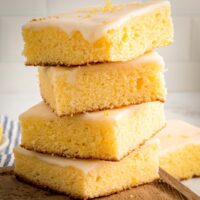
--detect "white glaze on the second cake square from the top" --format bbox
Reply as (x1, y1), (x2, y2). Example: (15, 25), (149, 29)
(46, 51), (165, 84)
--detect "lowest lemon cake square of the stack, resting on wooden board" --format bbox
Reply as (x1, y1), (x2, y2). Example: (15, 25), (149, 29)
(14, 139), (159, 199)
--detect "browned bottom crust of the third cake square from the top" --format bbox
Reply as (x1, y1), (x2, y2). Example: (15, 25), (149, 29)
(20, 123), (166, 162)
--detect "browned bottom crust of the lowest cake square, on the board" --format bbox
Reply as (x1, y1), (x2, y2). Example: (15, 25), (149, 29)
(14, 172), (159, 200)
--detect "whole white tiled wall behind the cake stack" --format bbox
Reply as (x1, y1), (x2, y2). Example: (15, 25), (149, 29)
(0, 0), (200, 93)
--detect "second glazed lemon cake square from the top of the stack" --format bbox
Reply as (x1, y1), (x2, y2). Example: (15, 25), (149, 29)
(39, 52), (166, 116)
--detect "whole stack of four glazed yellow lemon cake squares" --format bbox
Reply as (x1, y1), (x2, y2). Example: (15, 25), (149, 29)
(14, 1), (173, 199)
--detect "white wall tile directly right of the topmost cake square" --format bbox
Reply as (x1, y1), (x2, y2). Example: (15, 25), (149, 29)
(158, 17), (191, 61)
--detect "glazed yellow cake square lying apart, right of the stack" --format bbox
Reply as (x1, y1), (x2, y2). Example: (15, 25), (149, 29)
(159, 120), (200, 179)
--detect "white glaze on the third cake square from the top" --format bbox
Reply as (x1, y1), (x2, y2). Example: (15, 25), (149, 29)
(20, 102), (163, 121)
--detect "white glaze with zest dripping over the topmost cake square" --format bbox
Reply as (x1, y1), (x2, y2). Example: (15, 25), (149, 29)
(23, 0), (170, 42)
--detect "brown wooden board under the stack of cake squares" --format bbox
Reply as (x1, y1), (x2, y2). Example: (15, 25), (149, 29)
(0, 168), (200, 200)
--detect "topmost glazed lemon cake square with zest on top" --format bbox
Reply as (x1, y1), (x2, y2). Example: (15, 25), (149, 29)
(22, 1), (173, 66)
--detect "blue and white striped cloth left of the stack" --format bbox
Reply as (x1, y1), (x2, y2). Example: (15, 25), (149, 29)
(0, 116), (21, 167)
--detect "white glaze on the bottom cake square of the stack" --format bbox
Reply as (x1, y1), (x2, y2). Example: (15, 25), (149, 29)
(15, 138), (159, 174)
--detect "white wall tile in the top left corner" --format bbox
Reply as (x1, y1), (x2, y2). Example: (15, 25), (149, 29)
(0, 0), (46, 16)
